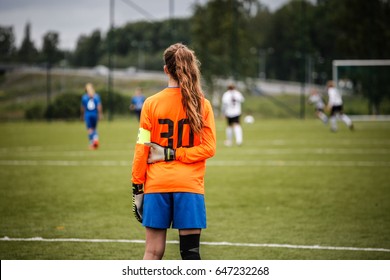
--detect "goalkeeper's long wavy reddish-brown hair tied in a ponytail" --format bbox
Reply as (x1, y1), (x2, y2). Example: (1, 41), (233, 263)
(164, 43), (204, 134)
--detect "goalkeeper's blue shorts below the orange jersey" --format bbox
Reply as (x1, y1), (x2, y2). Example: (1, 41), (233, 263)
(142, 193), (206, 229)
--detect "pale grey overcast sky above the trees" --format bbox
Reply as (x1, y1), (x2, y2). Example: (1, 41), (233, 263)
(0, 0), (289, 50)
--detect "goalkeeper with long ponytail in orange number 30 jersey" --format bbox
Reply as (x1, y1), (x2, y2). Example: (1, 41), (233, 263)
(132, 44), (216, 260)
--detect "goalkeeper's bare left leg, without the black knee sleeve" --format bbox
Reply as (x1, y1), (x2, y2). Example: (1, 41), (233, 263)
(144, 227), (167, 260)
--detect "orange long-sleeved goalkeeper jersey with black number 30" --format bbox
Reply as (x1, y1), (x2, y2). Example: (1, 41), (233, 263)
(132, 88), (216, 194)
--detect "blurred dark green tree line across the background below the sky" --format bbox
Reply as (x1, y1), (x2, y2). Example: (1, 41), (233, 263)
(0, 0), (390, 84)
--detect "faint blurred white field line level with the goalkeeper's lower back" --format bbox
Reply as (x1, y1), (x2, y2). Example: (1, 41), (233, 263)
(0, 159), (390, 167)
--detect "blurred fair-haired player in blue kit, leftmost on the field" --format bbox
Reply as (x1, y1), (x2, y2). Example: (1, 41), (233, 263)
(80, 83), (103, 150)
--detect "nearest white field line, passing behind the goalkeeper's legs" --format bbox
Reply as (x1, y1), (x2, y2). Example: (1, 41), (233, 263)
(0, 236), (390, 253)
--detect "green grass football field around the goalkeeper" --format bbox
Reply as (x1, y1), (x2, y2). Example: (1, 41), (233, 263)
(0, 119), (390, 260)
